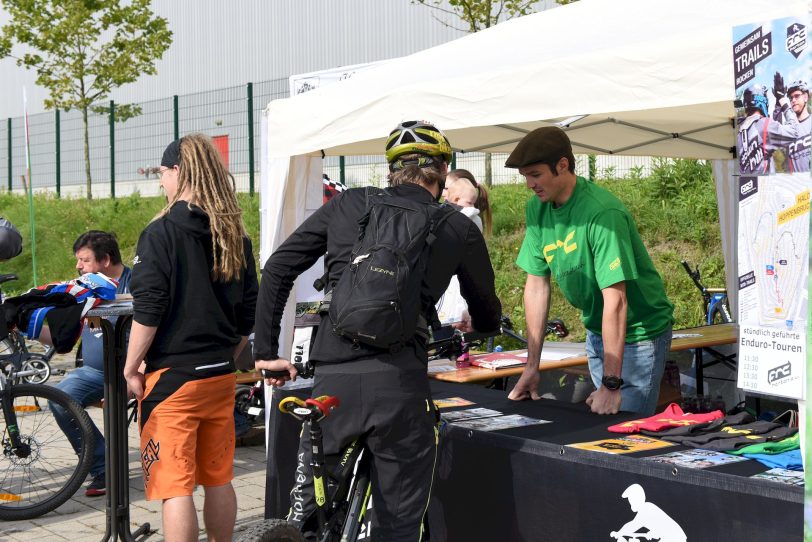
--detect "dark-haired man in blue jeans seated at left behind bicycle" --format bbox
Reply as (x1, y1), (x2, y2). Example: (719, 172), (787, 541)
(53, 230), (131, 497)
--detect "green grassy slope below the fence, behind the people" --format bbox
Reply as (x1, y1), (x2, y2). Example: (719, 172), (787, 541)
(0, 166), (724, 347)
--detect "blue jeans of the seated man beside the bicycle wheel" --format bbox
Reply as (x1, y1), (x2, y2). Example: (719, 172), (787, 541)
(51, 366), (104, 478)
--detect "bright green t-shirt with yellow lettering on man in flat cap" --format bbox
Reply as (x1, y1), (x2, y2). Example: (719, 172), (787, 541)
(516, 177), (674, 343)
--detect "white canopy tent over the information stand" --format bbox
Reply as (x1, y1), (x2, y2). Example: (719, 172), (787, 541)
(260, 0), (809, 356)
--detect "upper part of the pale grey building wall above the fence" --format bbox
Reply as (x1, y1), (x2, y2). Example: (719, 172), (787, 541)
(0, 0), (555, 119)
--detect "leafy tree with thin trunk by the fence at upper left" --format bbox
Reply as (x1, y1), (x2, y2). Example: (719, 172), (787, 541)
(0, 0), (172, 199)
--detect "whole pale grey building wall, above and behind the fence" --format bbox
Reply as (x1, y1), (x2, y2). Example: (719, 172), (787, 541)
(0, 0), (557, 195)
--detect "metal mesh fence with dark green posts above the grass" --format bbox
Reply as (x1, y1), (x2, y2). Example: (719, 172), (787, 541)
(0, 78), (651, 197)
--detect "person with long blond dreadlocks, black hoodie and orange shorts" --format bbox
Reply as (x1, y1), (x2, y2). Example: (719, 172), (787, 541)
(124, 134), (257, 542)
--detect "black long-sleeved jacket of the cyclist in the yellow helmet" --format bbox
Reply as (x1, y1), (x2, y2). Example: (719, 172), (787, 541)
(254, 183), (501, 363)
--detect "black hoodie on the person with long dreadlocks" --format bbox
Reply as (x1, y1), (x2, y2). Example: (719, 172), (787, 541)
(130, 201), (257, 371)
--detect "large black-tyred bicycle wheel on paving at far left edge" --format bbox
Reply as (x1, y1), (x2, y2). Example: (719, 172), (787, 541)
(0, 384), (95, 520)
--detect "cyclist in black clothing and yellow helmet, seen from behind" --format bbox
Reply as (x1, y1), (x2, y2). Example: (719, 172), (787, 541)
(254, 121), (501, 542)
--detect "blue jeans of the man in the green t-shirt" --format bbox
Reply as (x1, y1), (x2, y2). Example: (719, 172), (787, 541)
(586, 326), (671, 416)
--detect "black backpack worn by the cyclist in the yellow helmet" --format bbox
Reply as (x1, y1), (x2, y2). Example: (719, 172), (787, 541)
(329, 187), (456, 352)
